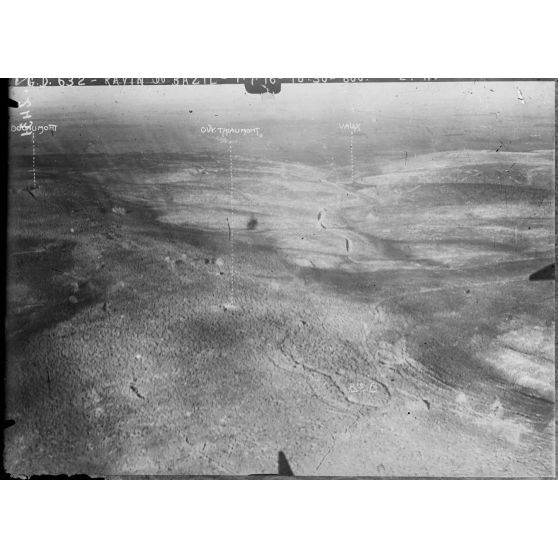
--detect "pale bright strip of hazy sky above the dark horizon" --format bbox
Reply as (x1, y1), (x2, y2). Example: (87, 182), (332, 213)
(11, 82), (554, 120)
